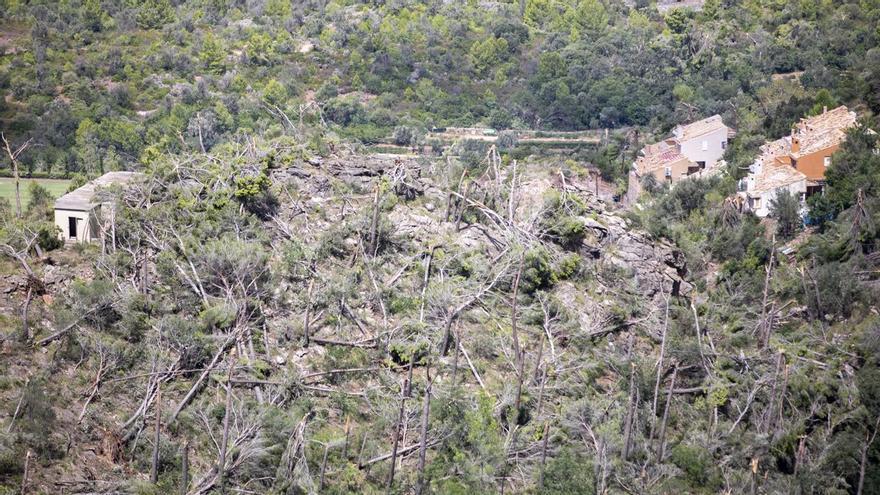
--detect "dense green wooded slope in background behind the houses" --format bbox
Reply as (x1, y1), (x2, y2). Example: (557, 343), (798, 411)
(0, 0), (880, 182)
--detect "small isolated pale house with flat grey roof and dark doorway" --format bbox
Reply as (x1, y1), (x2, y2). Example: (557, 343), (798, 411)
(55, 172), (142, 242)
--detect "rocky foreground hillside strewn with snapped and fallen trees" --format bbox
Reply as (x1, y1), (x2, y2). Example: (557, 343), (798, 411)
(2, 130), (878, 493)
